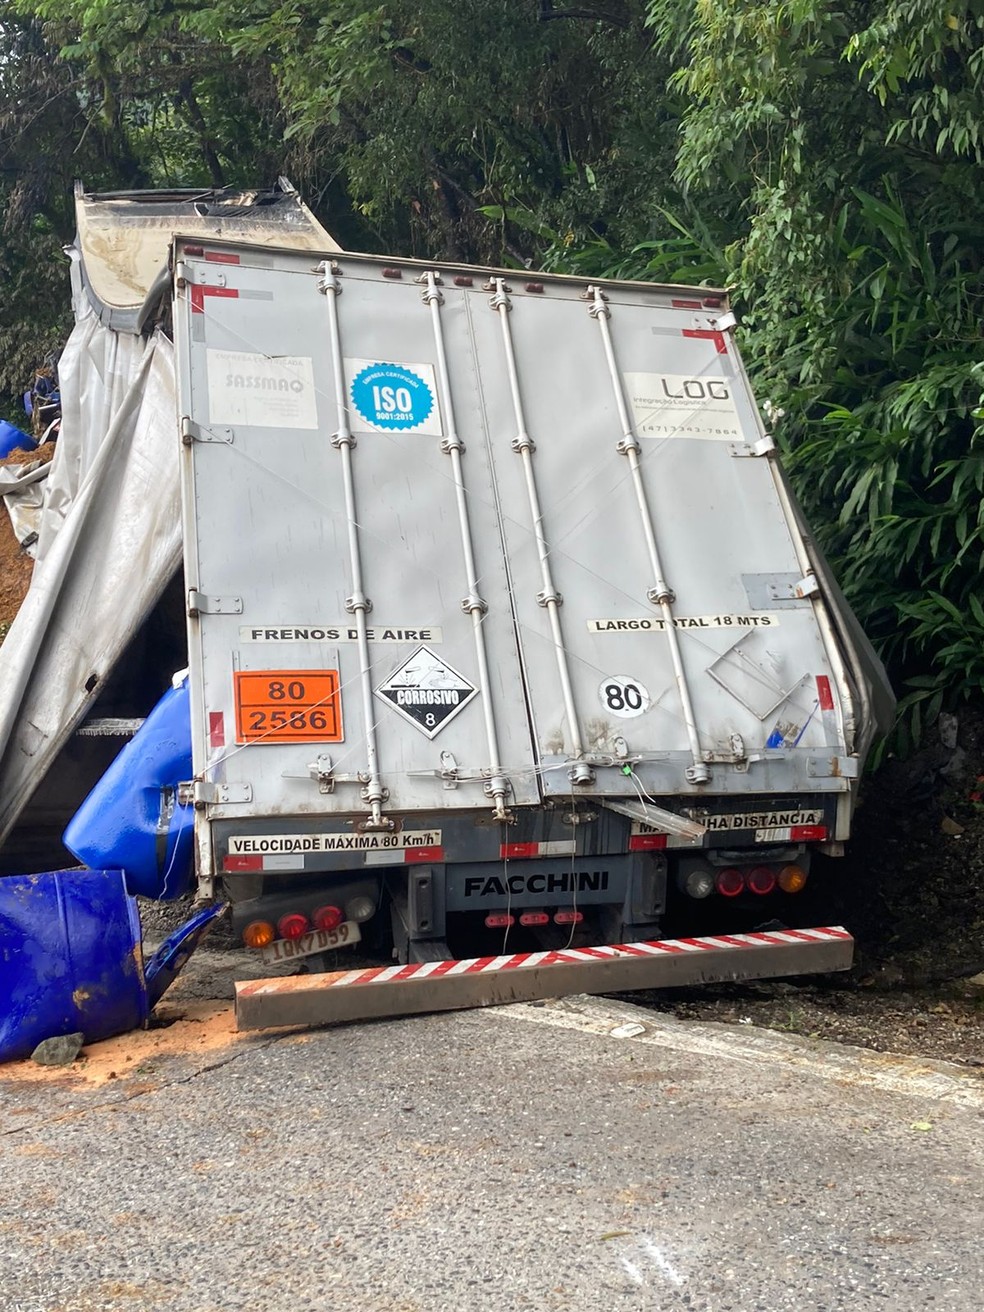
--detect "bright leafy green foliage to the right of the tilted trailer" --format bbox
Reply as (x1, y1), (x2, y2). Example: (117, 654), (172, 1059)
(648, 0), (984, 741)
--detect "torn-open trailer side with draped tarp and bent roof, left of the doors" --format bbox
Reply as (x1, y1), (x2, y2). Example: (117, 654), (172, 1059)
(0, 178), (335, 872)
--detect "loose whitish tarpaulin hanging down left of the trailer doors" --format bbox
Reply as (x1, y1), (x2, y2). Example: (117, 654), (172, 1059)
(0, 298), (181, 842)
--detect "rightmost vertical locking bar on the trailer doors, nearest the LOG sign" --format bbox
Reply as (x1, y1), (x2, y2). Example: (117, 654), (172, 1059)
(588, 286), (711, 783)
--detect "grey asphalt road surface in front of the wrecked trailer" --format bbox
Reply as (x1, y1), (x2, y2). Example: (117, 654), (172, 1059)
(0, 981), (984, 1312)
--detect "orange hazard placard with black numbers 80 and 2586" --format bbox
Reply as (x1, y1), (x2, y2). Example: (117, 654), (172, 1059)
(232, 669), (342, 743)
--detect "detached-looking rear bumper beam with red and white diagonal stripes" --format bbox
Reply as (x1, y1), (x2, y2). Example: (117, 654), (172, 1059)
(236, 926), (854, 1030)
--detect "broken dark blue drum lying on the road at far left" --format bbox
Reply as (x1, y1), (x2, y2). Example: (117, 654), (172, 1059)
(0, 870), (148, 1061)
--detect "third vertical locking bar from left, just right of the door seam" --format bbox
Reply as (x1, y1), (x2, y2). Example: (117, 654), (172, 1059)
(489, 278), (594, 785)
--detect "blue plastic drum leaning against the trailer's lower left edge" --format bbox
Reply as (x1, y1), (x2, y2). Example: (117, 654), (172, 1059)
(63, 680), (194, 901)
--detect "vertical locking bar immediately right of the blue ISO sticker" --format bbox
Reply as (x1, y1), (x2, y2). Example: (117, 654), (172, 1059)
(420, 270), (509, 820)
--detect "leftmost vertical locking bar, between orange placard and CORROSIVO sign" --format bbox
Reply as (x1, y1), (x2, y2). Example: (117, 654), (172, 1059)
(319, 264), (392, 829)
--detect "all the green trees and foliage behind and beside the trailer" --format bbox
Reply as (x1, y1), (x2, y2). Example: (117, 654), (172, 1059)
(0, 0), (984, 735)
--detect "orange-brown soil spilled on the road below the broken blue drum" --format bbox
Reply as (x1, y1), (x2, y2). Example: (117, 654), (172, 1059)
(0, 1002), (246, 1094)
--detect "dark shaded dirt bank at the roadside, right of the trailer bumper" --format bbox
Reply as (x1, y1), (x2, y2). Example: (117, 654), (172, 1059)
(651, 706), (984, 1078)
